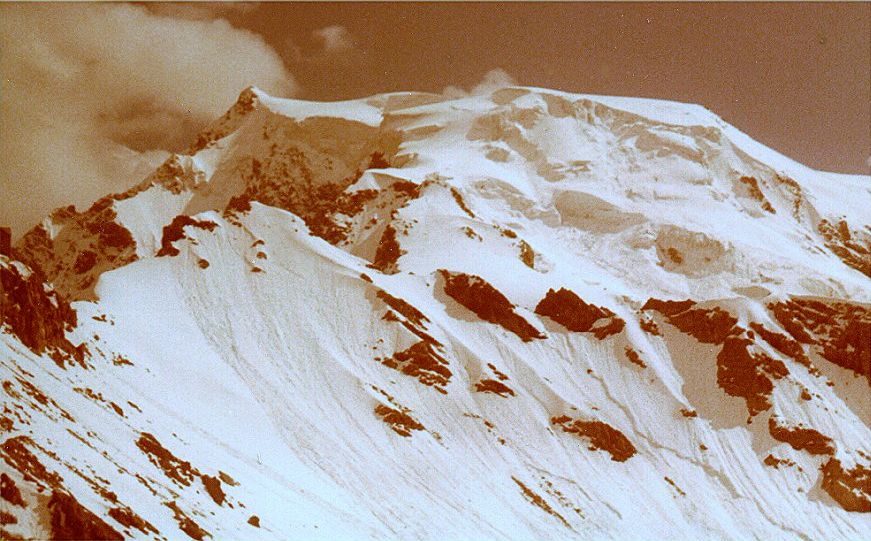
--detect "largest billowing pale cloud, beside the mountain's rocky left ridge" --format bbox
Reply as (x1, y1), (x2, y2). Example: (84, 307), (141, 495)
(0, 4), (296, 235)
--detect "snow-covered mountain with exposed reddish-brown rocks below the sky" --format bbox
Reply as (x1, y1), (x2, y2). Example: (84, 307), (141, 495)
(0, 87), (871, 540)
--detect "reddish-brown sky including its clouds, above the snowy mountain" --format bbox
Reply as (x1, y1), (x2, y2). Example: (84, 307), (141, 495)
(0, 3), (871, 237)
